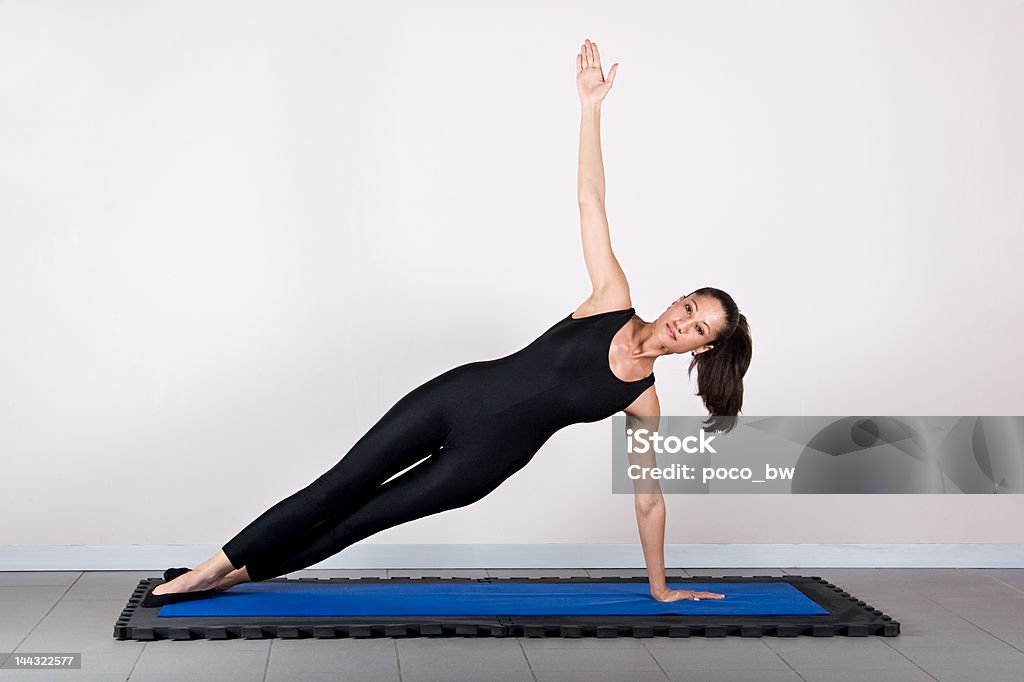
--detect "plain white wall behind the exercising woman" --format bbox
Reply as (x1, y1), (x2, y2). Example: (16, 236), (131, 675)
(0, 0), (1024, 545)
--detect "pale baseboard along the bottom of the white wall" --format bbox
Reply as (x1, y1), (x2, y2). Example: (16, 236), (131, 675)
(0, 543), (1024, 570)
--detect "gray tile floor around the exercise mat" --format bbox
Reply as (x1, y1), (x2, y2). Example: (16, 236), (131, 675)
(0, 568), (1024, 682)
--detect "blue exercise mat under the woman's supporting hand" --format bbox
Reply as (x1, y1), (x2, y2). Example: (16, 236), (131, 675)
(160, 582), (828, 617)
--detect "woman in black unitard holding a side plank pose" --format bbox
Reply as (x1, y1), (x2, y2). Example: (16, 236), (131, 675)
(142, 40), (751, 606)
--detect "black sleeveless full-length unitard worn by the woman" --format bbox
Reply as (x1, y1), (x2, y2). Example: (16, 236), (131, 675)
(223, 308), (654, 581)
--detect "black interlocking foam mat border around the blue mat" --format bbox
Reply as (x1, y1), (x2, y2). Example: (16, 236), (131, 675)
(114, 574), (900, 640)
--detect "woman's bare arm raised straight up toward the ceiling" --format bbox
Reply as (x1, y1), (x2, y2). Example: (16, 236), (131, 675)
(577, 40), (630, 314)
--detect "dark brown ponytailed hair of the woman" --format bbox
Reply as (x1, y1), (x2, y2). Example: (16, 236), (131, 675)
(686, 287), (753, 433)
